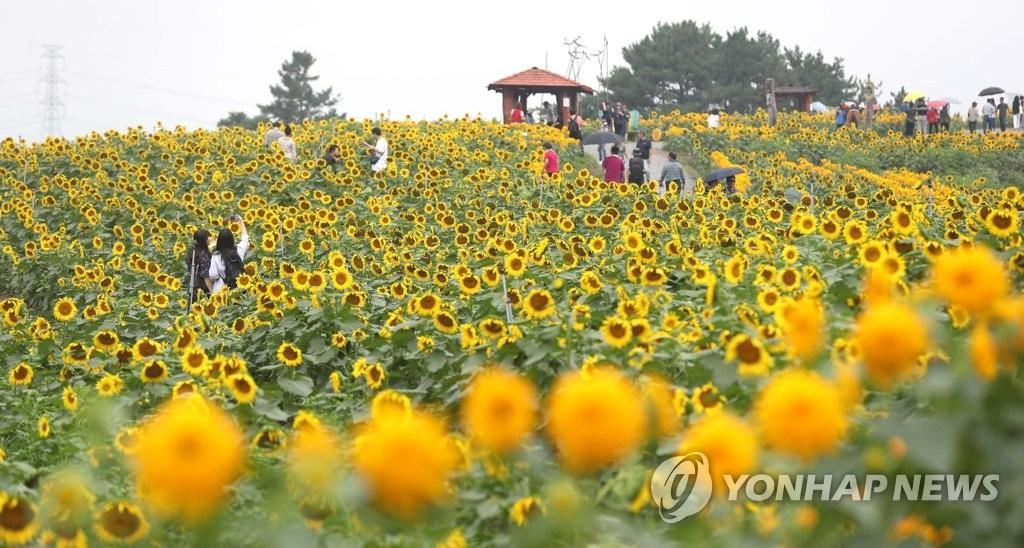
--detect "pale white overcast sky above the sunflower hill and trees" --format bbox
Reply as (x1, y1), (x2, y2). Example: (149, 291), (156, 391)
(0, 0), (1024, 140)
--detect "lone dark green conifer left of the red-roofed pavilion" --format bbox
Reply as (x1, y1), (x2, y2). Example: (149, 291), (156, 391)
(259, 51), (338, 123)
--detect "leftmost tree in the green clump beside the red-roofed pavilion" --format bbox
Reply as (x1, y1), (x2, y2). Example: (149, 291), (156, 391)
(602, 20), (721, 108)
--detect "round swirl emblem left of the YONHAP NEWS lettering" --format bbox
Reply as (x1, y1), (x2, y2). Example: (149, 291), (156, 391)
(650, 453), (712, 523)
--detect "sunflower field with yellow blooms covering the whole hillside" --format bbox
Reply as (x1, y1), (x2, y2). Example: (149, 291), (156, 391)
(0, 113), (1024, 548)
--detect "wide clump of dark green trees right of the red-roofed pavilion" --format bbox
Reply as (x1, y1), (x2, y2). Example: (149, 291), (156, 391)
(601, 20), (857, 112)
